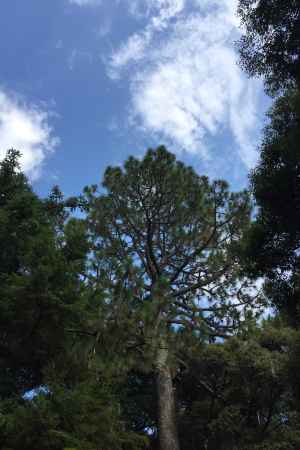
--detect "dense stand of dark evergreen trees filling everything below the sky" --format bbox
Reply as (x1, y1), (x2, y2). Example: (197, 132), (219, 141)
(0, 0), (300, 450)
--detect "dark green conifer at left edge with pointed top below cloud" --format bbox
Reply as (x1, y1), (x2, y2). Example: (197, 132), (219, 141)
(0, 150), (87, 397)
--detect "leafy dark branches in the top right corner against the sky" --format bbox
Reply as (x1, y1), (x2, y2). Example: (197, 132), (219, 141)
(238, 0), (300, 93)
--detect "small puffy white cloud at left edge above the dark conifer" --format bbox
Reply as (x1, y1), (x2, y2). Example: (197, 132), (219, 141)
(0, 90), (59, 178)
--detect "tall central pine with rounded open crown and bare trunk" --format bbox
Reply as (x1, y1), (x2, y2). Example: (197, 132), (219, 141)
(85, 147), (258, 450)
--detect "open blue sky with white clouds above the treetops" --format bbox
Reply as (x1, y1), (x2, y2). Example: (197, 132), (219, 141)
(0, 0), (269, 196)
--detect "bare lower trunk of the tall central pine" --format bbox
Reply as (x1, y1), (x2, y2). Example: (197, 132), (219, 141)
(156, 346), (180, 450)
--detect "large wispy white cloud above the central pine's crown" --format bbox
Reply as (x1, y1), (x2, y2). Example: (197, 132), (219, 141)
(108, 0), (261, 167)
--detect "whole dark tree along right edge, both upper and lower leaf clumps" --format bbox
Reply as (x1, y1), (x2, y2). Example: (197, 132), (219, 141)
(238, 0), (300, 325)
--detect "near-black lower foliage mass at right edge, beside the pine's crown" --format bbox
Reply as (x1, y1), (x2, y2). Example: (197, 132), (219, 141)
(246, 91), (300, 324)
